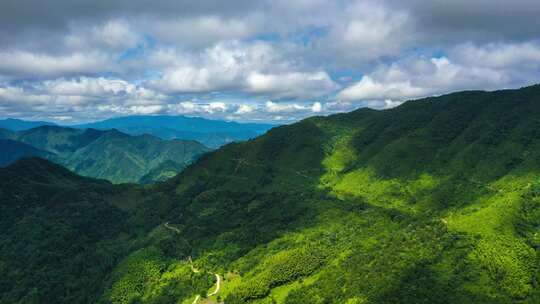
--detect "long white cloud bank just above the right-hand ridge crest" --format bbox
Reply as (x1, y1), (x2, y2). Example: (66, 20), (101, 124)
(338, 43), (540, 102)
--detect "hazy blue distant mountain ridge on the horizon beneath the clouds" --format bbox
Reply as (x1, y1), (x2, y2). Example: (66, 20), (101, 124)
(73, 116), (274, 148)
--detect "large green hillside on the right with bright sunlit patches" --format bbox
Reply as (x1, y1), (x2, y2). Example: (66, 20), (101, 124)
(106, 86), (540, 303)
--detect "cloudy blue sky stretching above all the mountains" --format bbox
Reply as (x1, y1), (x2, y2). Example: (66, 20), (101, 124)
(0, 0), (540, 123)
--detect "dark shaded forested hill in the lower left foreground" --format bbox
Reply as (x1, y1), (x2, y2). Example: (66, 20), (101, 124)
(0, 158), (140, 303)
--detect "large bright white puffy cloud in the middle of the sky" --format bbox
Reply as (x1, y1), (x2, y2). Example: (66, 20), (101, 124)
(143, 42), (337, 99)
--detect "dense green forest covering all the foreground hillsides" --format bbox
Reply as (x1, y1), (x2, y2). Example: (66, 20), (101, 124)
(0, 86), (540, 304)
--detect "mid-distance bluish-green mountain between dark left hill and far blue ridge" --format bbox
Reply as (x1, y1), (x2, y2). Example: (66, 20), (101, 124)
(0, 126), (209, 183)
